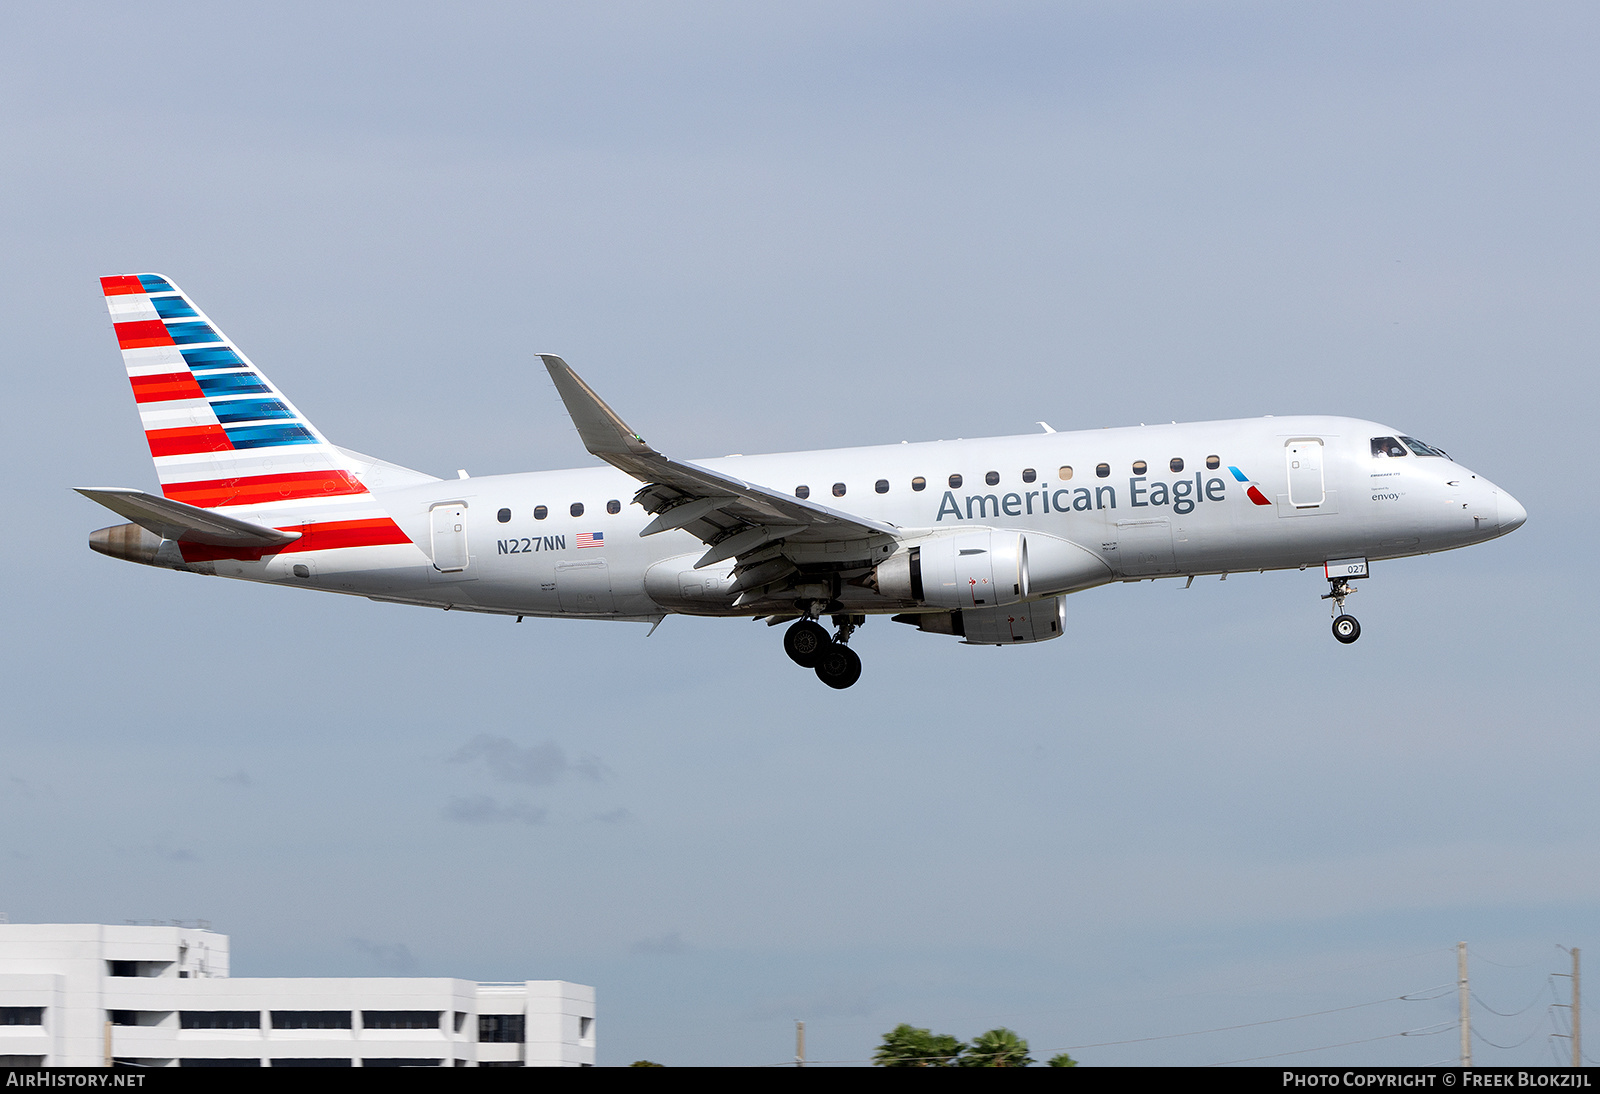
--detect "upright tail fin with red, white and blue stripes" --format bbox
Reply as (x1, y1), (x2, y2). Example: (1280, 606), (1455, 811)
(101, 274), (366, 509)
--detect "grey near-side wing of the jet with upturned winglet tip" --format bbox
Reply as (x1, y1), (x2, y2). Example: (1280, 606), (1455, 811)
(541, 353), (899, 605)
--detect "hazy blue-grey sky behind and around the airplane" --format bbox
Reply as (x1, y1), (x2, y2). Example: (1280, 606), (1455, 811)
(0, 0), (1600, 1065)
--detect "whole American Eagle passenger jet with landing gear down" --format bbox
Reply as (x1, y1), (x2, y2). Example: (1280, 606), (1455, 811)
(78, 274), (1528, 689)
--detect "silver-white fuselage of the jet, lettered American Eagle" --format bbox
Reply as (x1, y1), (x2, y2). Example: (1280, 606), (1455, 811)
(203, 416), (1526, 619)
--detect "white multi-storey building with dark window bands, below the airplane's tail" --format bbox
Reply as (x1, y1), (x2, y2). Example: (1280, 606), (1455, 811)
(0, 923), (595, 1067)
